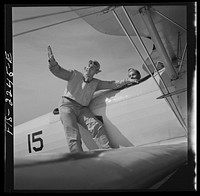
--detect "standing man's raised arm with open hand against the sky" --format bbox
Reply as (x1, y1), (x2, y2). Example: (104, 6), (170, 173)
(48, 46), (73, 81)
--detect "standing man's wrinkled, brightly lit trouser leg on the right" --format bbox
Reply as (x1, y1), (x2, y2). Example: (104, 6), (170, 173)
(78, 108), (110, 149)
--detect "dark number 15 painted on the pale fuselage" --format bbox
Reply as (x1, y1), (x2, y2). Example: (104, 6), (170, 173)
(28, 131), (44, 153)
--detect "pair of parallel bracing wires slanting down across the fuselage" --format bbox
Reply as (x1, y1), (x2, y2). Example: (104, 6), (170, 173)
(112, 6), (187, 133)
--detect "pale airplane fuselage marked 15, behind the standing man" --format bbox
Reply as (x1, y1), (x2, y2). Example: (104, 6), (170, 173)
(14, 69), (187, 157)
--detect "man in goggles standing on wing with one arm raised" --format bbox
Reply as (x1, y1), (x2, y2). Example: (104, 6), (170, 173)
(48, 46), (137, 152)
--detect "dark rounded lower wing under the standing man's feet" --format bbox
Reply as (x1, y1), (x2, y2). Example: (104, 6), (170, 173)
(15, 143), (187, 190)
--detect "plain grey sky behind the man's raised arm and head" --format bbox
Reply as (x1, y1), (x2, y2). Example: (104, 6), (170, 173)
(12, 6), (152, 126)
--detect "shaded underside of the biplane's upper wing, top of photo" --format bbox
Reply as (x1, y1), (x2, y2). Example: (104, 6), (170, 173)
(70, 5), (187, 63)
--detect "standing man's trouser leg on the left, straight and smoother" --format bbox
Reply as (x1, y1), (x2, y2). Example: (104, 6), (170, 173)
(60, 108), (83, 152)
